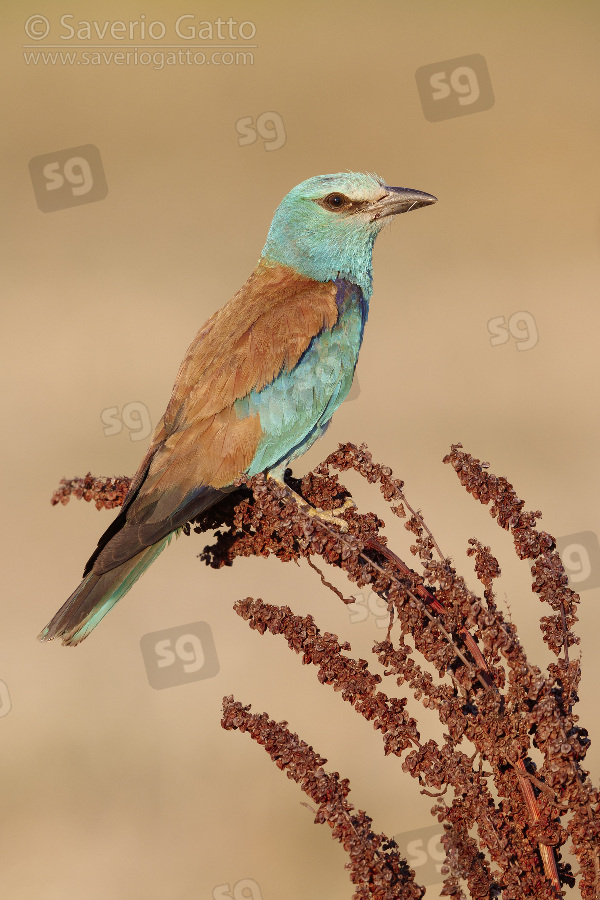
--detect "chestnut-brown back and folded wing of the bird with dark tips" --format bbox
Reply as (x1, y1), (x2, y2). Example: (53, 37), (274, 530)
(91, 261), (338, 572)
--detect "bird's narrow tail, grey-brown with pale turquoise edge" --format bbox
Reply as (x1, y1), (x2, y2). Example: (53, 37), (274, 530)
(38, 532), (175, 646)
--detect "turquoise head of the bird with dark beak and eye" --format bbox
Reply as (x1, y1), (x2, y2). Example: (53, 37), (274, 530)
(262, 172), (436, 299)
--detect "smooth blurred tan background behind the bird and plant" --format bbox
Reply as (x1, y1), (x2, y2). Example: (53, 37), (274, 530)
(0, 0), (600, 900)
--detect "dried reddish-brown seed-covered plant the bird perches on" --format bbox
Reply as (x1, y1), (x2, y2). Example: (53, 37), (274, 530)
(52, 444), (600, 900)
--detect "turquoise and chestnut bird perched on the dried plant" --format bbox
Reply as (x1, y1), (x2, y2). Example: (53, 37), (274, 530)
(39, 172), (436, 645)
